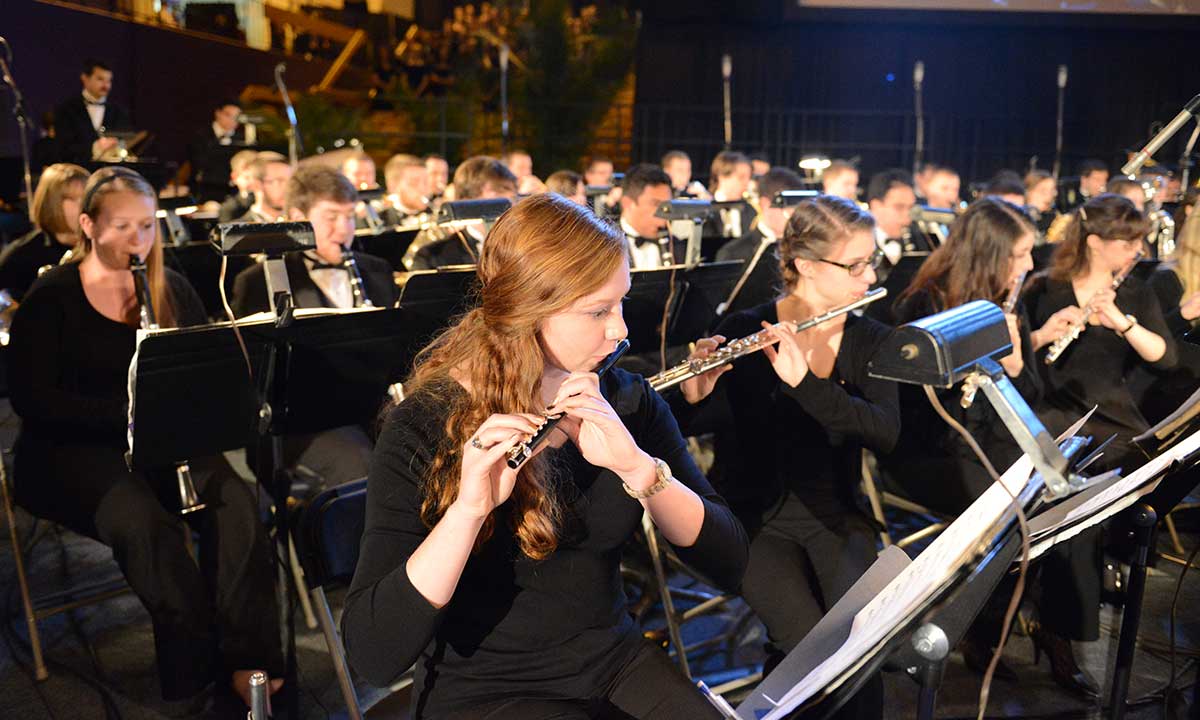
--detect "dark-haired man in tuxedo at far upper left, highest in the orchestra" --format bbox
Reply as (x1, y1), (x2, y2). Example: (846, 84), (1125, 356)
(54, 59), (132, 163)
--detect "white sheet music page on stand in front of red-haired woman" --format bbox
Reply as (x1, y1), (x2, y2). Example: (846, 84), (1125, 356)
(763, 456), (1033, 720)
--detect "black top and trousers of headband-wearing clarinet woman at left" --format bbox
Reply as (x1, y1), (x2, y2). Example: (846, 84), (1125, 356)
(8, 263), (283, 700)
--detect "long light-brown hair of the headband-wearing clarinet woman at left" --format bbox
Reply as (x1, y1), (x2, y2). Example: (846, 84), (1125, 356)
(72, 167), (175, 328)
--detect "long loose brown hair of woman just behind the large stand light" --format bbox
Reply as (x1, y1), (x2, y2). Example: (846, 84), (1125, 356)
(896, 196), (1037, 311)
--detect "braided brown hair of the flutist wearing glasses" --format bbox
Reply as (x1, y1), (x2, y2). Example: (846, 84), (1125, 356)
(779, 196), (875, 290)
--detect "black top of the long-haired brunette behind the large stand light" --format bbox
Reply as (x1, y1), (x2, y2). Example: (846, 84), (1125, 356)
(889, 290), (1044, 473)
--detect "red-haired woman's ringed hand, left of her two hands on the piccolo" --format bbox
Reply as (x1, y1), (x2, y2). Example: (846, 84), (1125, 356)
(454, 413), (546, 518)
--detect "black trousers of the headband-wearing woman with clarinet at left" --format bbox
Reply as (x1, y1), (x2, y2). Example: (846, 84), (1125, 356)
(16, 442), (284, 701)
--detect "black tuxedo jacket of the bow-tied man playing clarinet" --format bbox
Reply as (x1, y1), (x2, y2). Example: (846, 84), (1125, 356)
(229, 252), (398, 318)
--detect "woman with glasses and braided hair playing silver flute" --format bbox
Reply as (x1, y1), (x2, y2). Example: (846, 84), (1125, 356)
(672, 196), (900, 718)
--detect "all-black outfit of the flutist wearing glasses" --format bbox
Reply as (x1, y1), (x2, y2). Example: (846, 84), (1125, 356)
(672, 302), (900, 650)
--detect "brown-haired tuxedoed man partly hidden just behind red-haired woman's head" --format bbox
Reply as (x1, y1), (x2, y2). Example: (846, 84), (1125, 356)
(403, 155), (517, 270)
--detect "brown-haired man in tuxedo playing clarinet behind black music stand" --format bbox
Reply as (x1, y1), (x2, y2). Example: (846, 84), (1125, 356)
(232, 164), (398, 490)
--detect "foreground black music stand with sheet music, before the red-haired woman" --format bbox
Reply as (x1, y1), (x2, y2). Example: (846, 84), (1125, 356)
(731, 460), (1044, 720)
